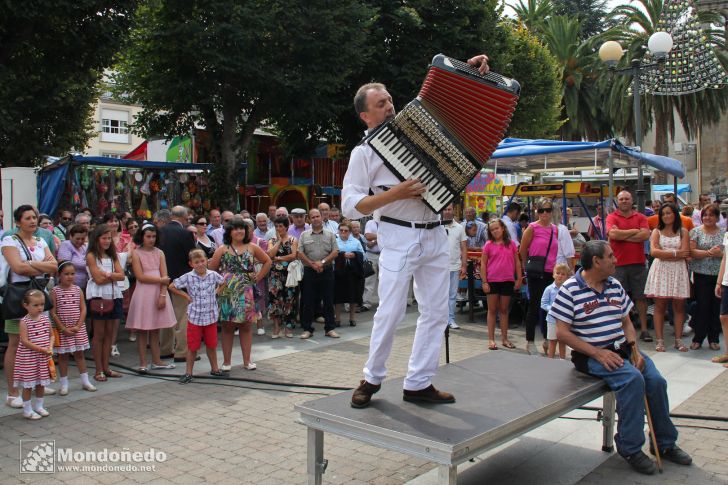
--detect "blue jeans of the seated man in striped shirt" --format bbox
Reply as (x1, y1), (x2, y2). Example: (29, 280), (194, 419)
(588, 354), (677, 457)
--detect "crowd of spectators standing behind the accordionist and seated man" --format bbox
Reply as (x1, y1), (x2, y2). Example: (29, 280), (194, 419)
(2, 191), (728, 419)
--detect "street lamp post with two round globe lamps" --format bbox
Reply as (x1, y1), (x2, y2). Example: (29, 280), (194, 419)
(599, 32), (672, 212)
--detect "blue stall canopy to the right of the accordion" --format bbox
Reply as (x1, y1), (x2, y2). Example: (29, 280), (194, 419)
(491, 138), (685, 177)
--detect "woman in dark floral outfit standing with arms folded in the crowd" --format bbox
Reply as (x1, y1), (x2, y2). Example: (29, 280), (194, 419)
(268, 217), (298, 338)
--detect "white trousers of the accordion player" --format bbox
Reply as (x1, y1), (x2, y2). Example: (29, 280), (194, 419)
(364, 223), (450, 391)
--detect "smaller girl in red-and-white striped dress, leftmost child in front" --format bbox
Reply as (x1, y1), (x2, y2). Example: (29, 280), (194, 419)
(13, 290), (53, 420)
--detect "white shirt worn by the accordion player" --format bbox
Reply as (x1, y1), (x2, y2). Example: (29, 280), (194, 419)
(341, 134), (439, 222)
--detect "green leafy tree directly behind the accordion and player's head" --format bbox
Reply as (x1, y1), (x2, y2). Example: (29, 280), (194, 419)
(337, 0), (559, 147)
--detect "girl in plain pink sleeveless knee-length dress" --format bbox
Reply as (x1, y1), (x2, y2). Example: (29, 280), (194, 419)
(126, 224), (177, 373)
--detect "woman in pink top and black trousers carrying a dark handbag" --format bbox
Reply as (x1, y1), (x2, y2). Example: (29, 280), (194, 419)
(520, 198), (559, 355)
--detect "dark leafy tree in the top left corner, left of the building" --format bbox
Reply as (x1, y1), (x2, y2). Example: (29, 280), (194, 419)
(0, 0), (137, 166)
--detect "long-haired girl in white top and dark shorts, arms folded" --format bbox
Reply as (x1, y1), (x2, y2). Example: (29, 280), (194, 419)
(86, 224), (124, 382)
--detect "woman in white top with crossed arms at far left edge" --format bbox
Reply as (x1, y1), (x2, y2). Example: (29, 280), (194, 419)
(2, 204), (57, 408)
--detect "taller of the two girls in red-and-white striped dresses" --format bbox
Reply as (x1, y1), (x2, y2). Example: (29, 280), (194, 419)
(50, 260), (96, 396)
